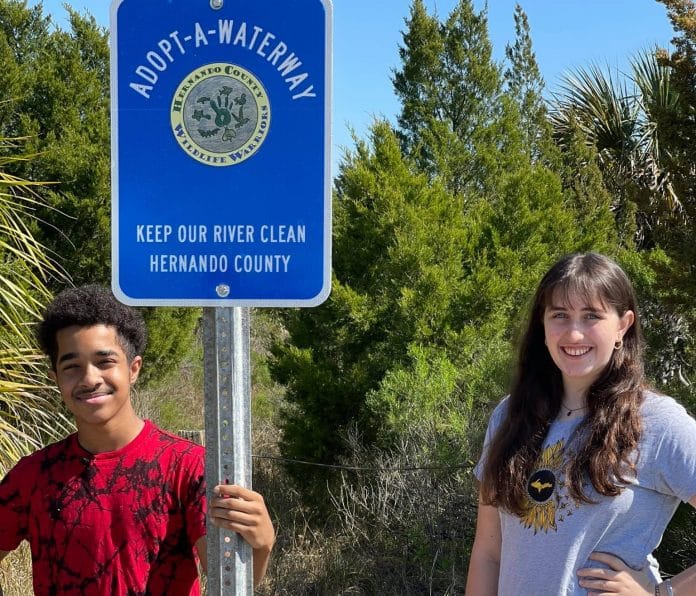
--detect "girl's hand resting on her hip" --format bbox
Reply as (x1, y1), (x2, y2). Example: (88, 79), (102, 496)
(578, 551), (655, 596)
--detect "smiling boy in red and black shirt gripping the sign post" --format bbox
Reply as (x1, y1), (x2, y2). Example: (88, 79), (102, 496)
(0, 286), (274, 596)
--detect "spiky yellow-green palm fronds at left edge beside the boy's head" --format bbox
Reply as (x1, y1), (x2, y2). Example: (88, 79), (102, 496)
(0, 139), (72, 475)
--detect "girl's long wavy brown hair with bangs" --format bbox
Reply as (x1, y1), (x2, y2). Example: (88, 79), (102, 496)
(481, 253), (644, 515)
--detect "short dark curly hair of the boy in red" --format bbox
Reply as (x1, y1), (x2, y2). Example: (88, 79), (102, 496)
(36, 285), (147, 370)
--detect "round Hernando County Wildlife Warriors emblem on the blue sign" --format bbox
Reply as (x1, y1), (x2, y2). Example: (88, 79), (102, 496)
(171, 62), (271, 166)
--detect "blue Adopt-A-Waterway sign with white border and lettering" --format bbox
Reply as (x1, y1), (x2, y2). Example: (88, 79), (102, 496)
(111, 0), (331, 306)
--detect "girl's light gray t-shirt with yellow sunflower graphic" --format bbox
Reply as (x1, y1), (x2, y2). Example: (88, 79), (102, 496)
(474, 393), (696, 596)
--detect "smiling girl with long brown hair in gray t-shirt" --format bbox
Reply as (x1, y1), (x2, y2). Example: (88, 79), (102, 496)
(467, 253), (696, 596)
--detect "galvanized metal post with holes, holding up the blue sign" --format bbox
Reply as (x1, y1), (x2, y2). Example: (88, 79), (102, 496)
(203, 307), (253, 596)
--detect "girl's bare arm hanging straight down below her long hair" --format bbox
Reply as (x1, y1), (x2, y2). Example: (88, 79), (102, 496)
(466, 500), (502, 596)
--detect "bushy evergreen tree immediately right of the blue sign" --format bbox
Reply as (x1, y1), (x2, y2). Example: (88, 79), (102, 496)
(273, 123), (466, 461)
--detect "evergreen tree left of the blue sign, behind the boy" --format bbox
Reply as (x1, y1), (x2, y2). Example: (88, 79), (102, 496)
(0, 0), (199, 388)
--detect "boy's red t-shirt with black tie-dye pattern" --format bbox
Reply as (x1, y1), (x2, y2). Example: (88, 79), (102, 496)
(0, 421), (205, 596)
